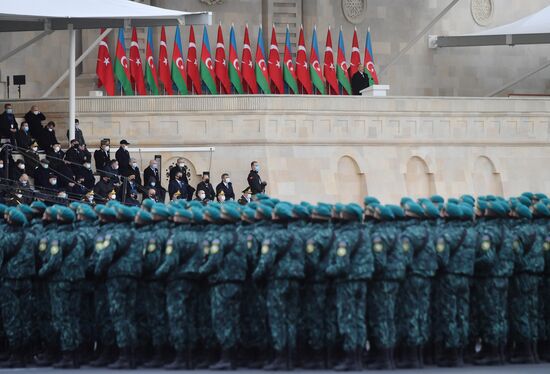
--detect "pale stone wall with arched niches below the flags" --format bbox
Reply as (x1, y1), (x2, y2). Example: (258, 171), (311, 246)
(4, 96), (550, 202)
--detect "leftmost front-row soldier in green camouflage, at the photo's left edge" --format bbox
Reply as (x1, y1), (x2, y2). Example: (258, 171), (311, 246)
(0, 208), (35, 368)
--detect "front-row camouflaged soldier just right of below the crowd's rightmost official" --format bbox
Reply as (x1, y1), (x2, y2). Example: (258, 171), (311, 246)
(253, 203), (304, 370)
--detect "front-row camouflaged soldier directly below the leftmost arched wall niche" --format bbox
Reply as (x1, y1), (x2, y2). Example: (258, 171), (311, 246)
(326, 204), (374, 371)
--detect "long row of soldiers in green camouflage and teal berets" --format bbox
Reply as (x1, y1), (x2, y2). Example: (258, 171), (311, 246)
(0, 193), (550, 370)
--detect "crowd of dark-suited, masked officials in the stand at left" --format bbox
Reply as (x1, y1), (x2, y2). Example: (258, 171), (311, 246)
(0, 104), (267, 206)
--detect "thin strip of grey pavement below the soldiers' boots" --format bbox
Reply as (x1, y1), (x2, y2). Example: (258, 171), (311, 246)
(4, 363), (550, 374)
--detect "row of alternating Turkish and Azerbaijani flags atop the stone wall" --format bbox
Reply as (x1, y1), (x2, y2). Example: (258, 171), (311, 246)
(96, 24), (378, 96)
